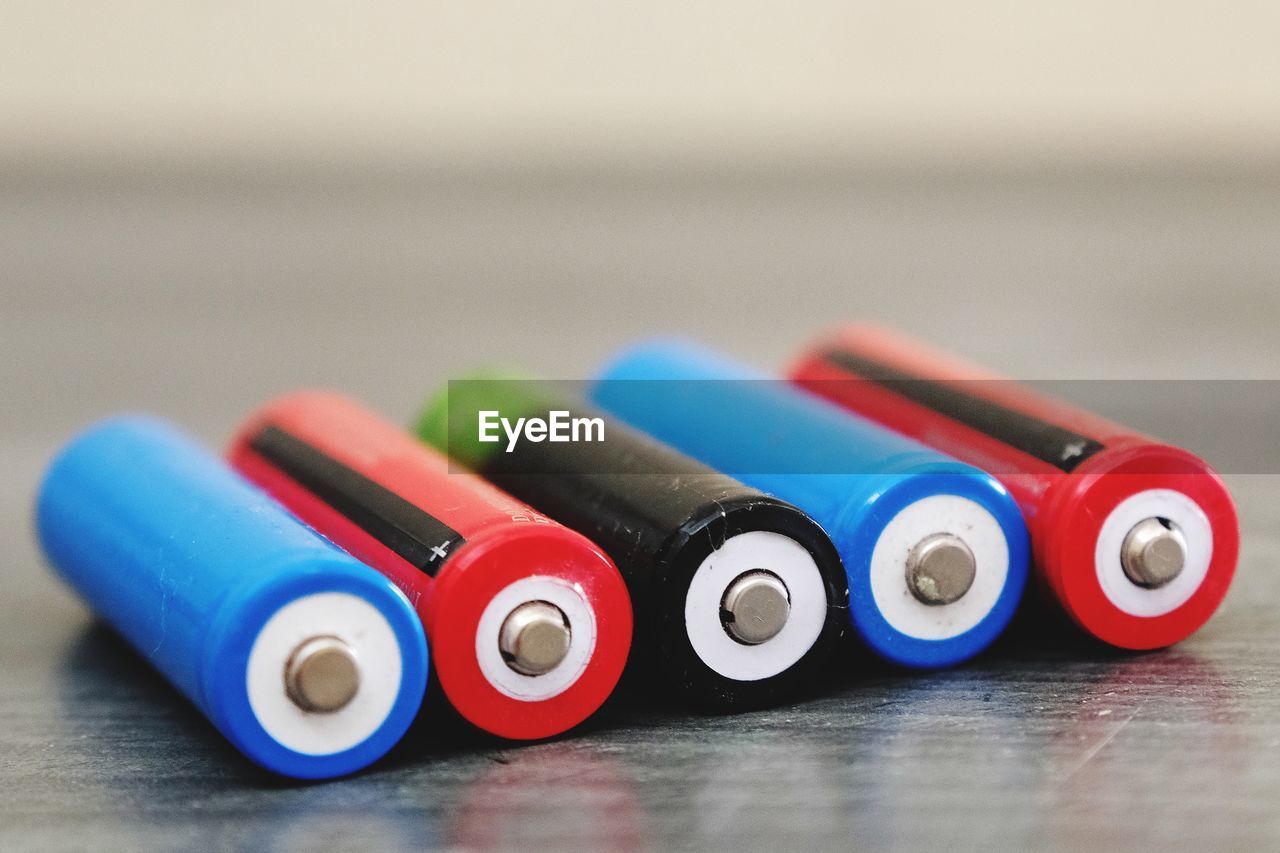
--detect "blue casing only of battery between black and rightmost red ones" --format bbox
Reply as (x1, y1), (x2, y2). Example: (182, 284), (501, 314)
(589, 341), (1028, 669)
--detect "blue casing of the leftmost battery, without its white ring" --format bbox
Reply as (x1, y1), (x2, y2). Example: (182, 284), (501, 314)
(36, 416), (428, 779)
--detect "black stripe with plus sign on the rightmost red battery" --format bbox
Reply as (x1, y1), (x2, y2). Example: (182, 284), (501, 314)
(822, 350), (1102, 474)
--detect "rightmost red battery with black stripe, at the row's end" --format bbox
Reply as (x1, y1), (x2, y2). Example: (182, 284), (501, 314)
(790, 325), (1240, 649)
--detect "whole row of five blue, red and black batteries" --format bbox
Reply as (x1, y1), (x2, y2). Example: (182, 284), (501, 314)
(37, 328), (1239, 779)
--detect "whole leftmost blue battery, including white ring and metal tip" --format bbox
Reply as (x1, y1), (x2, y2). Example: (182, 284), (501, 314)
(36, 416), (428, 779)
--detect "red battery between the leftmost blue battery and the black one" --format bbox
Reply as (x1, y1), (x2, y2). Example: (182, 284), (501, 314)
(228, 392), (631, 740)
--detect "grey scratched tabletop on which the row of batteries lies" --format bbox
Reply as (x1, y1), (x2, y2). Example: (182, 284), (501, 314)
(0, 167), (1280, 852)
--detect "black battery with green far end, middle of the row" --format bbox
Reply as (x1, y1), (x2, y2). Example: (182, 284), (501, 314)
(417, 375), (849, 712)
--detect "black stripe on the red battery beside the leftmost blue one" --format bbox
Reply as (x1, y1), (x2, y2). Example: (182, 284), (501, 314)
(250, 427), (466, 575)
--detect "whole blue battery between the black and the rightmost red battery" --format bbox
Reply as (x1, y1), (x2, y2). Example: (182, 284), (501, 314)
(590, 341), (1028, 669)
